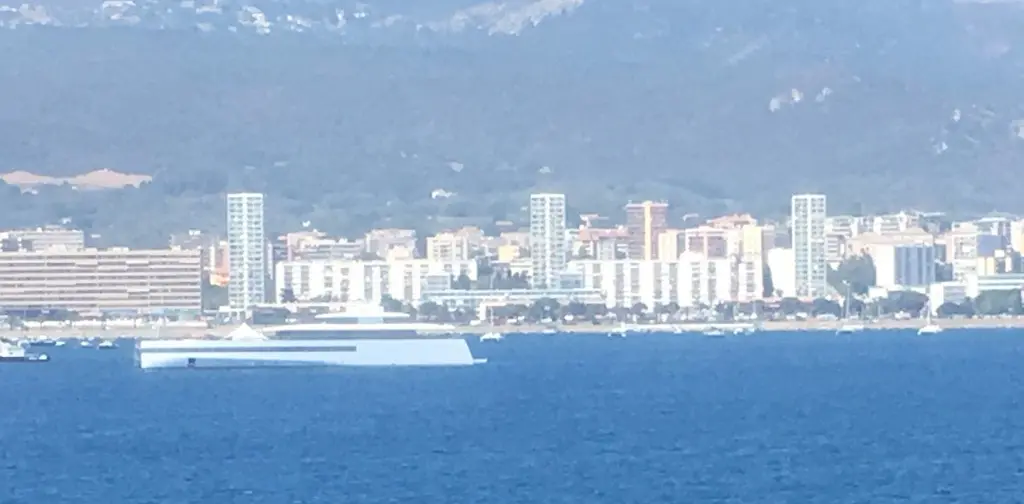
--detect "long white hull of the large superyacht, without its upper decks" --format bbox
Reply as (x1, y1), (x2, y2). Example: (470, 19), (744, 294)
(136, 338), (477, 369)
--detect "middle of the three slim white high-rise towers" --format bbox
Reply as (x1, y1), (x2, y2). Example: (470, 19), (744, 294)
(529, 194), (567, 289)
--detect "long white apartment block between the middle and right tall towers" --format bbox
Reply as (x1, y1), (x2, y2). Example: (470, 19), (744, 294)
(568, 253), (762, 308)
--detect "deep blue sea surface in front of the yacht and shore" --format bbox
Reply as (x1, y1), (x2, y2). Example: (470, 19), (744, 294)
(0, 331), (1024, 504)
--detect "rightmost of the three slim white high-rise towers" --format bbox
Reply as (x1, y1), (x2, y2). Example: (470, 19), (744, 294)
(791, 195), (828, 298)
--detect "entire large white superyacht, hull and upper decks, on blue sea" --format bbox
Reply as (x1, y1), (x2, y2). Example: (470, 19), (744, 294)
(136, 306), (485, 369)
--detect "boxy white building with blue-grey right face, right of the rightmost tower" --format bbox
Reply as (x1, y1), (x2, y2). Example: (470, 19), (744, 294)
(870, 244), (935, 290)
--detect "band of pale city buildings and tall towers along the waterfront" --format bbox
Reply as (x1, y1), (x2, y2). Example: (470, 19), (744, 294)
(0, 193), (1024, 312)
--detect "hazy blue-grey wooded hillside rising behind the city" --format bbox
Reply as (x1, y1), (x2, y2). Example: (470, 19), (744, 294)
(0, 0), (1024, 243)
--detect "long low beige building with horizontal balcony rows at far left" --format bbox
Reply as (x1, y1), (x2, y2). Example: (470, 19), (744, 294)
(0, 249), (203, 313)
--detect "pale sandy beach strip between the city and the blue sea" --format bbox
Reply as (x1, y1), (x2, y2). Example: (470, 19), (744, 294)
(0, 317), (1024, 340)
